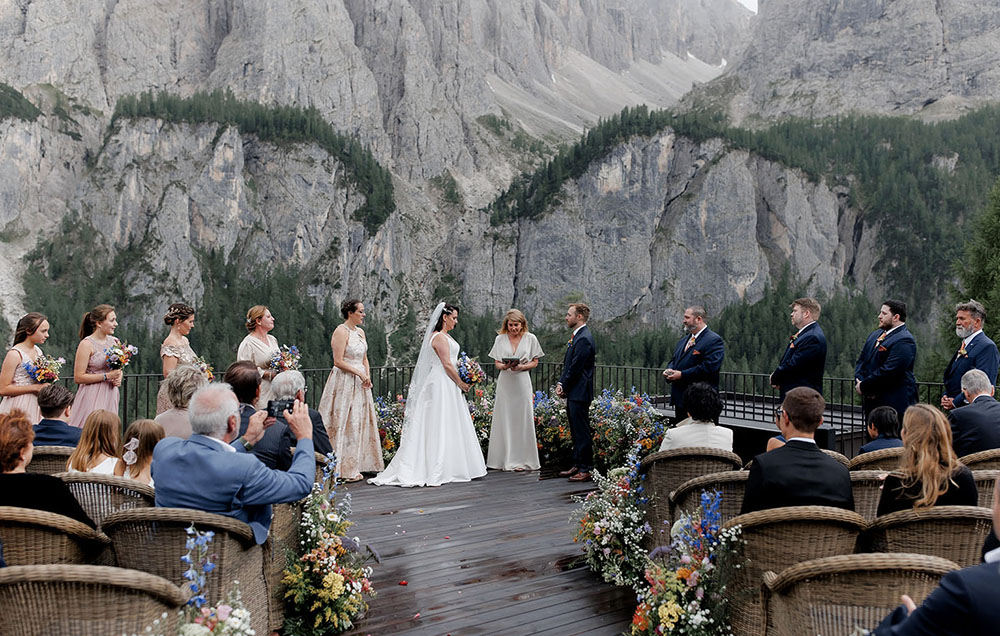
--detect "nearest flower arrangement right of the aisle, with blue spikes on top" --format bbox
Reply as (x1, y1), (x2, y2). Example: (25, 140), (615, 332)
(630, 491), (743, 636)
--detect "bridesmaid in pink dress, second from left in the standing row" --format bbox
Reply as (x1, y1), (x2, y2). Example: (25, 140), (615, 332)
(69, 305), (122, 428)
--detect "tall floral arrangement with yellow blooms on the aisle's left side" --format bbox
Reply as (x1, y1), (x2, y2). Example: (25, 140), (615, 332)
(282, 453), (375, 636)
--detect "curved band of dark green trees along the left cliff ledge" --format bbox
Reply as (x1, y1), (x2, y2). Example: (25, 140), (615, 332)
(111, 90), (396, 233)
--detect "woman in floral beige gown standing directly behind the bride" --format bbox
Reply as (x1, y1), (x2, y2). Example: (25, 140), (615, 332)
(319, 299), (385, 481)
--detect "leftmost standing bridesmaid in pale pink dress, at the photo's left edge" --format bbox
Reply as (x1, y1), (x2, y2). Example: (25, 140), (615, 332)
(0, 312), (49, 425)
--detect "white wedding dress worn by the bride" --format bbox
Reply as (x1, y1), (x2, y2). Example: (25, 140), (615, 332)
(368, 333), (486, 486)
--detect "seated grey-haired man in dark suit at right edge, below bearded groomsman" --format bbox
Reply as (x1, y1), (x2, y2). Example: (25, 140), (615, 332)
(948, 369), (1000, 457)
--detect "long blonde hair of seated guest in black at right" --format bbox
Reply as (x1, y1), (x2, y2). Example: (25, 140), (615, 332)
(899, 404), (962, 508)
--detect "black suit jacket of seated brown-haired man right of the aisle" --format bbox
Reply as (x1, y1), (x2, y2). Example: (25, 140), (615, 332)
(740, 440), (854, 514)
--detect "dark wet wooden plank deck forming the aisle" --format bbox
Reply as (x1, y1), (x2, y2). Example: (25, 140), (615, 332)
(346, 471), (635, 636)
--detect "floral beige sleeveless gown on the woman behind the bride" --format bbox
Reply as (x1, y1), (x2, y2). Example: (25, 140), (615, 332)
(319, 329), (385, 479)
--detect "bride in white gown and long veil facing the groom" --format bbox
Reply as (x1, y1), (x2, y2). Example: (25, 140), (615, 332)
(368, 303), (486, 486)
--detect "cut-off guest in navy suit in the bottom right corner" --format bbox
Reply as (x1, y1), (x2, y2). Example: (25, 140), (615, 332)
(873, 474), (1000, 636)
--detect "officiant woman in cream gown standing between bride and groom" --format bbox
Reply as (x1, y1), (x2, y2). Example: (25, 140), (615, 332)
(486, 309), (545, 471)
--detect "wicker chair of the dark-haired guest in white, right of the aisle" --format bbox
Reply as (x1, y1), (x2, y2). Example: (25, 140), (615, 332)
(639, 446), (742, 538)
